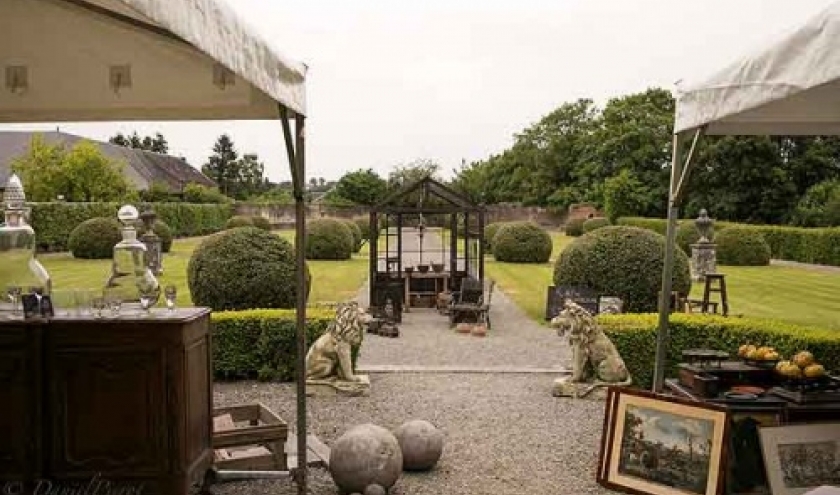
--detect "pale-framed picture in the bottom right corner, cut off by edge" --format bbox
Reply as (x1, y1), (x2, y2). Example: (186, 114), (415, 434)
(758, 423), (840, 495)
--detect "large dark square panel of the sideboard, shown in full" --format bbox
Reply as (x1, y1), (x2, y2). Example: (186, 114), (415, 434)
(48, 344), (169, 476)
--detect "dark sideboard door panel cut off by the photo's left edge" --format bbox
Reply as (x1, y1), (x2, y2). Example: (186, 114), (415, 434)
(0, 324), (42, 482)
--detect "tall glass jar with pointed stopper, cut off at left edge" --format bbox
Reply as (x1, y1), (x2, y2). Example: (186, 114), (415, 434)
(0, 174), (52, 298)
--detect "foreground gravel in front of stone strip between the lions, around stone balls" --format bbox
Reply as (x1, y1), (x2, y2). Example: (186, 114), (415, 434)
(212, 374), (612, 495)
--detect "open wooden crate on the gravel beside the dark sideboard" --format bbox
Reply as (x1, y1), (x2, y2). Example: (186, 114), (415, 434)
(213, 403), (289, 471)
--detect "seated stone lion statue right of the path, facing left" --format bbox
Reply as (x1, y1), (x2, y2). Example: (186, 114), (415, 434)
(551, 299), (632, 397)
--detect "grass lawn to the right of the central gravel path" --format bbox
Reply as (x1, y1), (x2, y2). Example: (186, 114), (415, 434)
(484, 233), (840, 329)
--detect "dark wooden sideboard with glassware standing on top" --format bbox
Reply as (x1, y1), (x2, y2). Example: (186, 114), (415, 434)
(0, 308), (213, 495)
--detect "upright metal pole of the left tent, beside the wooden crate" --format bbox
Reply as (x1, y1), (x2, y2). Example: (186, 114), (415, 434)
(294, 114), (309, 495)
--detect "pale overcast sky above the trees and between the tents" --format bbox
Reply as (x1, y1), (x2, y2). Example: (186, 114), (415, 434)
(3, 0), (832, 180)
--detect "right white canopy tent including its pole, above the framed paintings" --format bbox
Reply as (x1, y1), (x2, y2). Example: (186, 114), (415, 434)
(653, 2), (840, 391)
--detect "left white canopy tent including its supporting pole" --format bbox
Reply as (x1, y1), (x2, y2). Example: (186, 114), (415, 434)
(0, 0), (307, 493)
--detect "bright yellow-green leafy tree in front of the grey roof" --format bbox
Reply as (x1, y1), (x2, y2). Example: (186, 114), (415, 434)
(12, 136), (132, 202)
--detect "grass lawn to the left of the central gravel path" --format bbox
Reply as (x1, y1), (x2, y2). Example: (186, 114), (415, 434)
(38, 230), (369, 305)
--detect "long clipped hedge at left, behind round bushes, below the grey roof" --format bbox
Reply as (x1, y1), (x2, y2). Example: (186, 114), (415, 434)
(29, 203), (233, 251)
